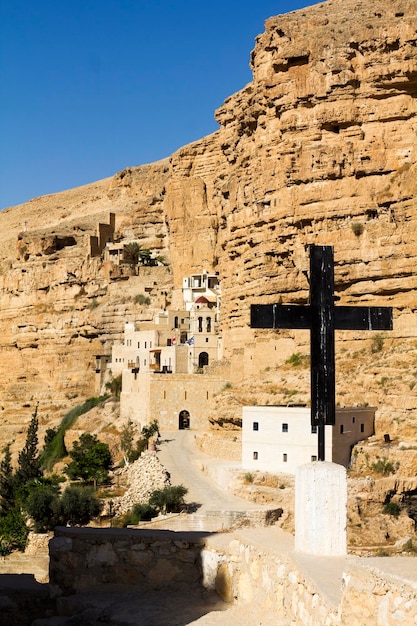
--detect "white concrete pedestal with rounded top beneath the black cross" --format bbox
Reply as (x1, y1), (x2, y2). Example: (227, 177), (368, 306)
(295, 461), (347, 556)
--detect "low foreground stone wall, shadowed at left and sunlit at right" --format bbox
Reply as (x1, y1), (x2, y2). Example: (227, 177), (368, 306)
(49, 528), (417, 626)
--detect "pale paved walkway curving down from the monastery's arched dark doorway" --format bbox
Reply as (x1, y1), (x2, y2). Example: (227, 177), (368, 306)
(157, 430), (270, 514)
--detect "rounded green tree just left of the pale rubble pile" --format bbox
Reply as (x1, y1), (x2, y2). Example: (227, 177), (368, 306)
(64, 433), (112, 487)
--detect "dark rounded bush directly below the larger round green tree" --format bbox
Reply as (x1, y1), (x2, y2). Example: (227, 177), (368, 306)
(58, 486), (102, 526)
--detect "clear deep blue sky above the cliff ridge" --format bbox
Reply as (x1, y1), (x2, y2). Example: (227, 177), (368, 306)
(0, 0), (315, 209)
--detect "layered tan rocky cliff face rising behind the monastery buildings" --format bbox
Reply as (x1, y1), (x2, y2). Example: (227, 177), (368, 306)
(0, 0), (417, 450)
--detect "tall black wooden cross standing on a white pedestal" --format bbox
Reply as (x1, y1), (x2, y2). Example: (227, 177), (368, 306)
(251, 245), (393, 461)
